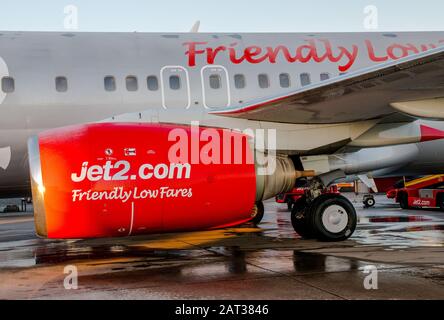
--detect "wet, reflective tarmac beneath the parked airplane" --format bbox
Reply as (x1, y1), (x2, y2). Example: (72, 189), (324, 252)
(0, 197), (444, 300)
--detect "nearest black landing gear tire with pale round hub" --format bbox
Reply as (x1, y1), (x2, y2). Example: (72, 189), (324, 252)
(311, 194), (358, 242)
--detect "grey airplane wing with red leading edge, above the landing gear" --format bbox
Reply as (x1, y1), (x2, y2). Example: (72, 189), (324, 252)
(213, 47), (444, 124)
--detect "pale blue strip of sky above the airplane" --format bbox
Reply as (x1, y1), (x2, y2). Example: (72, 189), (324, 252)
(0, 0), (444, 32)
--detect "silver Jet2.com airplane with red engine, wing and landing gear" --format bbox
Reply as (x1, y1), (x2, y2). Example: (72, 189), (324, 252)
(0, 32), (444, 241)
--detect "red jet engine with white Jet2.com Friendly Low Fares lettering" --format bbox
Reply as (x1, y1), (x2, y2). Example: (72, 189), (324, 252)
(28, 123), (306, 239)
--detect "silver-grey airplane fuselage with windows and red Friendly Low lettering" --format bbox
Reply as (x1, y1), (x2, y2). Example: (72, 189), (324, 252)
(0, 32), (444, 196)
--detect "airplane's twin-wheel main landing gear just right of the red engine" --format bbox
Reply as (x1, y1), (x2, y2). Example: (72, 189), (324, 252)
(291, 174), (357, 242)
